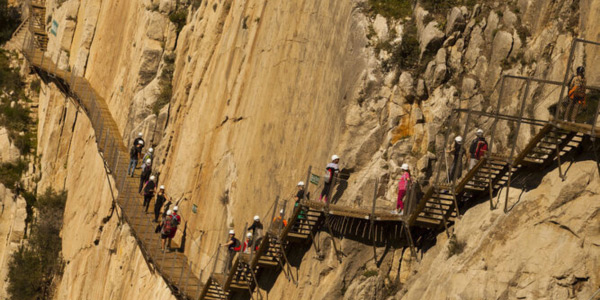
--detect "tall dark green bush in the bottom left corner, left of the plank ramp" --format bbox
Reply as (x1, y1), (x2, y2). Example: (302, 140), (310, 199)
(7, 189), (67, 300)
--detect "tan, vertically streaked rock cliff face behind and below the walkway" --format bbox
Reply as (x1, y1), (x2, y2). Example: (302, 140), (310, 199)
(4, 0), (600, 299)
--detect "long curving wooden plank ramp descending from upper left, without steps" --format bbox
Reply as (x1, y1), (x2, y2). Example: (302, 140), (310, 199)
(20, 27), (202, 299)
